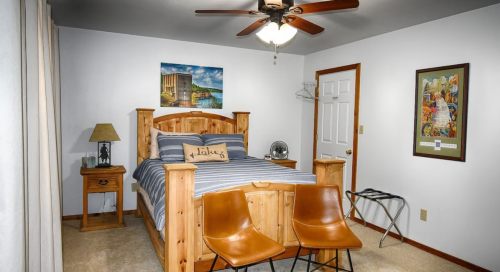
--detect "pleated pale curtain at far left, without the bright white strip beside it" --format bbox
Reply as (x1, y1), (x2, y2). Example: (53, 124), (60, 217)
(23, 0), (63, 271)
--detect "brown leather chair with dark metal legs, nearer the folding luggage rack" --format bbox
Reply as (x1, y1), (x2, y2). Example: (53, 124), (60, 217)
(291, 184), (363, 272)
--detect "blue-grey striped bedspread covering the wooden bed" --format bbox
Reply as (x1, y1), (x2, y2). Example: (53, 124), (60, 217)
(133, 157), (316, 231)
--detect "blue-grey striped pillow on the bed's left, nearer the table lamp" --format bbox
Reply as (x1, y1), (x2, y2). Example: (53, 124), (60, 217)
(157, 133), (203, 161)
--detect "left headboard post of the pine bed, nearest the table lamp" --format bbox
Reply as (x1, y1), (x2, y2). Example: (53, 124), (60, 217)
(135, 109), (155, 217)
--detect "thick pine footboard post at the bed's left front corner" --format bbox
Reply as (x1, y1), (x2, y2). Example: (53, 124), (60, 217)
(163, 163), (198, 272)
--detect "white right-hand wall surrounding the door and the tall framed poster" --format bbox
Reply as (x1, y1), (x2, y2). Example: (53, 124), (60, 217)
(301, 4), (500, 271)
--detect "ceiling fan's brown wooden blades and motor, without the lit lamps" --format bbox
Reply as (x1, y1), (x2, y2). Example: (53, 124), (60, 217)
(196, 0), (359, 38)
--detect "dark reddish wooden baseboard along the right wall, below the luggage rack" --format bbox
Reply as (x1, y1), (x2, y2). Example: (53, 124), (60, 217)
(351, 218), (491, 272)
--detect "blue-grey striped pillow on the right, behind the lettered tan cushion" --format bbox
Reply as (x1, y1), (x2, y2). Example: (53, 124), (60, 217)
(203, 134), (247, 160)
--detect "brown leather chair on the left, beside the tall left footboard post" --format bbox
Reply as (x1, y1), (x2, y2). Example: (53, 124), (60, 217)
(202, 189), (285, 272)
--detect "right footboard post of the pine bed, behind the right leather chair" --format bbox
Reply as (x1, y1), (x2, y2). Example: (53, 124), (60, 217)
(314, 159), (345, 271)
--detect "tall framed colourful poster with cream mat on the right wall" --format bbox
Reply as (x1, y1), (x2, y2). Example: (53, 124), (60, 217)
(413, 63), (469, 162)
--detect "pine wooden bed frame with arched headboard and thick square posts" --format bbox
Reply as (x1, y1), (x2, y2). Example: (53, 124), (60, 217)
(136, 109), (344, 272)
